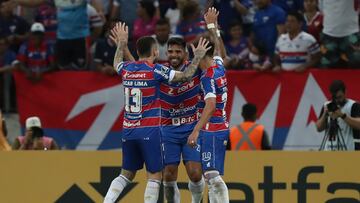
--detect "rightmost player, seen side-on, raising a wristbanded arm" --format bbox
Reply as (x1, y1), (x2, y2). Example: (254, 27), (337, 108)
(188, 8), (229, 203)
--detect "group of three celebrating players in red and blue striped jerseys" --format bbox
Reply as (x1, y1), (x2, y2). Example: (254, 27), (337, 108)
(104, 8), (229, 203)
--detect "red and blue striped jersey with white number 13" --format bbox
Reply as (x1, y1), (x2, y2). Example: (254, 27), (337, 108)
(116, 61), (174, 139)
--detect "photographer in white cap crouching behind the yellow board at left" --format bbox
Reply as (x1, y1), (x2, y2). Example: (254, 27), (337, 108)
(13, 117), (59, 150)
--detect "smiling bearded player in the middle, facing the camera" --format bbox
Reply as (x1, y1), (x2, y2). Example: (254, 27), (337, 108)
(160, 37), (205, 203)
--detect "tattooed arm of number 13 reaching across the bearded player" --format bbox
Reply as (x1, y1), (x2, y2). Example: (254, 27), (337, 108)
(171, 38), (211, 82)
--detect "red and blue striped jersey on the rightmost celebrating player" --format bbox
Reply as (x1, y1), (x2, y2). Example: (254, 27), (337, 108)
(198, 57), (229, 132)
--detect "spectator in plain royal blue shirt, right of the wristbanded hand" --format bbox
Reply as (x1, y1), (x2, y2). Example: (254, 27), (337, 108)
(253, 0), (286, 56)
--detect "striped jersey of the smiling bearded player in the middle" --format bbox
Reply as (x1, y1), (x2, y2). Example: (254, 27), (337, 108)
(160, 62), (201, 138)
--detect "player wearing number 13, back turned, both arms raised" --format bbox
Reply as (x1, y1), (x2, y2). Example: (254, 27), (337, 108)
(104, 23), (210, 203)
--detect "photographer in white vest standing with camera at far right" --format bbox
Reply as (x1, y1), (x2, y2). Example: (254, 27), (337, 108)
(316, 80), (360, 151)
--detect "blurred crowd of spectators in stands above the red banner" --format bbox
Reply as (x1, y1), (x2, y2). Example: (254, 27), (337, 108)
(0, 0), (360, 111)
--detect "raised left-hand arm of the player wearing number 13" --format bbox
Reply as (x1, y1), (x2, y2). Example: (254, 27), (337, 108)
(109, 23), (129, 72)
